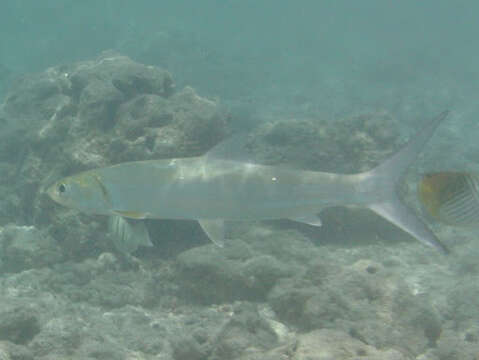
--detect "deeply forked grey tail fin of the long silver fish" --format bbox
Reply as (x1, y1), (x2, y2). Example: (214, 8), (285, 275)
(361, 111), (449, 253)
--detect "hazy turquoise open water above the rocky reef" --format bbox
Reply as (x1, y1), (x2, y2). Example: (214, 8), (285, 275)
(0, 0), (478, 112)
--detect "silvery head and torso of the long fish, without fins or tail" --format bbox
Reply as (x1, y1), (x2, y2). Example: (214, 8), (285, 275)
(50, 157), (364, 220)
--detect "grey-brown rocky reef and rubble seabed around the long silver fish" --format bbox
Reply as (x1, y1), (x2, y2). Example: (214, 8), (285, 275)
(0, 52), (479, 360)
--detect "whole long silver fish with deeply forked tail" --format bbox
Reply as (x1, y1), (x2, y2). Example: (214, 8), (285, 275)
(48, 112), (447, 251)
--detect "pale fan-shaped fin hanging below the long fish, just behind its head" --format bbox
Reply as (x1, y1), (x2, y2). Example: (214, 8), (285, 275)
(108, 216), (153, 254)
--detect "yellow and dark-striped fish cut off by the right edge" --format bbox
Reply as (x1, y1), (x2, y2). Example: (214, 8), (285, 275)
(418, 171), (479, 226)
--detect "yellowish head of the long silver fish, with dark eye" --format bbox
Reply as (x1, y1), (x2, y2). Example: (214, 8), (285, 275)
(47, 171), (110, 214)
